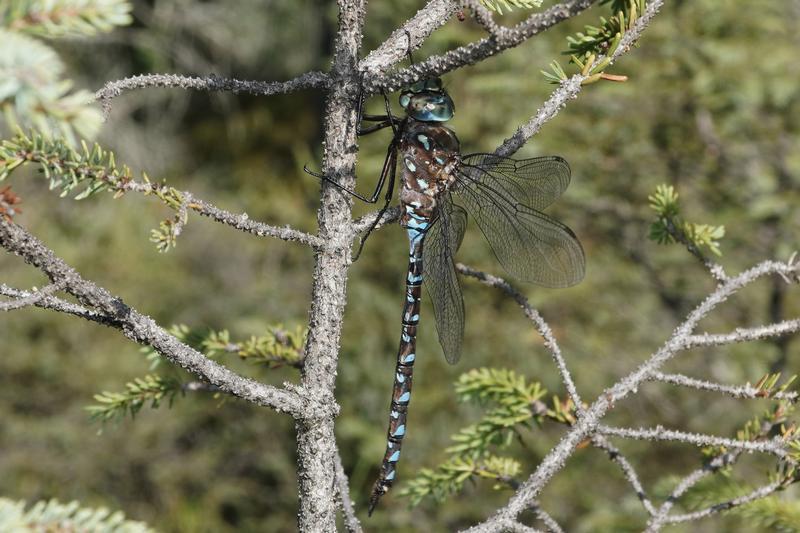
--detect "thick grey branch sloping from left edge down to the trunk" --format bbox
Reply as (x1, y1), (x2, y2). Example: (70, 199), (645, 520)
(0, 217), (309, 417)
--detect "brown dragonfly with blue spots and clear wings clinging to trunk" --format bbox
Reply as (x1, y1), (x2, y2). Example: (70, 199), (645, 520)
(306, 78), (585, 515)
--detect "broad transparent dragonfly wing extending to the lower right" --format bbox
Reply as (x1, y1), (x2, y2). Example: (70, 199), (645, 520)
(456, 160), (585, 287)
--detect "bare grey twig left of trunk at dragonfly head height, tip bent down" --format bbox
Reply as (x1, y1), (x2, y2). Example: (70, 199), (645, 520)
(94, 71), (330, 115)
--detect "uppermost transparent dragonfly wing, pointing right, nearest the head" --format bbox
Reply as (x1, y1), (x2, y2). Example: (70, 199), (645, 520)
(460, 154), (570, 210)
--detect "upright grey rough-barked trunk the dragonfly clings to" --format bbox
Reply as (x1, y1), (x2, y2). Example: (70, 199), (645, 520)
(297, 0), (364, 531)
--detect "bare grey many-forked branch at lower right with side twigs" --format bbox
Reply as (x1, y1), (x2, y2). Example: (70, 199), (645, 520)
(457, 260), (800, 532)
